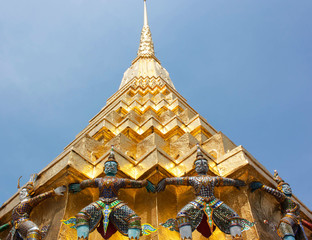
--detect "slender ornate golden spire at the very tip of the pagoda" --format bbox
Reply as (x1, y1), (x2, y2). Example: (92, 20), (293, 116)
(138, 0), (155, 57)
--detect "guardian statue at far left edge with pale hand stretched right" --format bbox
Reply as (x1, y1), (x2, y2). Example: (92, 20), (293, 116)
(4, 174), (66, 240)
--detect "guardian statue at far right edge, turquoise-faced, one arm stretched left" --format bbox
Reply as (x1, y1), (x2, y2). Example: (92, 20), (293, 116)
(249, 170), (308, 240)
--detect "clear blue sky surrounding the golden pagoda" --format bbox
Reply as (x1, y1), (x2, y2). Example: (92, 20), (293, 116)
(0, 0), (312, 208)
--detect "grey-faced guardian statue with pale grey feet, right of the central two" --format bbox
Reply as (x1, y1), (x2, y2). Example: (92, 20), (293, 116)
(157, 145), (253, 240)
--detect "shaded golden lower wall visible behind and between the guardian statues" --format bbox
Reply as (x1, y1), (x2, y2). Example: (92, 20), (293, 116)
(0, 168), (312, 240)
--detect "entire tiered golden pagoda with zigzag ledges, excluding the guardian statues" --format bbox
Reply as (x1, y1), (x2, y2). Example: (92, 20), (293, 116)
(0, 1), (312, 240)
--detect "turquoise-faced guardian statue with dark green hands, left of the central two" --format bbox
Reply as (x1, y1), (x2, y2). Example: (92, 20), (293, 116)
(64, 148), (156, 239)
